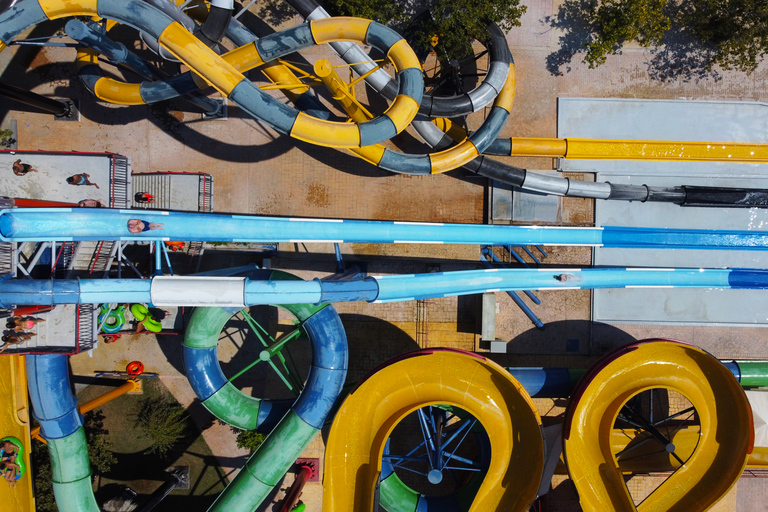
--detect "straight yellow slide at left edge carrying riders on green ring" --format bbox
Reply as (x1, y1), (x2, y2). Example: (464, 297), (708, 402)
(0, 355), (35, 512)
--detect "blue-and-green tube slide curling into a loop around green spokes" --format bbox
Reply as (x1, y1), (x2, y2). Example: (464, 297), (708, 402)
(183, 271), (348, 512)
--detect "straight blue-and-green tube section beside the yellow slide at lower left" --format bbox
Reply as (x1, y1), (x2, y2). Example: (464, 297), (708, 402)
(27, 354), (99, 512)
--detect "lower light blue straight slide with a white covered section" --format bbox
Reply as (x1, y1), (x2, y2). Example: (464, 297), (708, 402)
(0, 268), (768, 308)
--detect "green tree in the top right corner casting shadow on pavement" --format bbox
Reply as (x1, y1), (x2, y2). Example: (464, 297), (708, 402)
(584, 0), (768, 73)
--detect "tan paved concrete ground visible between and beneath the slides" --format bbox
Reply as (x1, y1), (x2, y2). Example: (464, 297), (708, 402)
(0, 0), (768, 510)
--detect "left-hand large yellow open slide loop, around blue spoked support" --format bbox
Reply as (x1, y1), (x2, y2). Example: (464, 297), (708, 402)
(323, 349), (544, 512)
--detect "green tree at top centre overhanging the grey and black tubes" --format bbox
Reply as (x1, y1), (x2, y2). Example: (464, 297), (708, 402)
(325, 0), (526, 64)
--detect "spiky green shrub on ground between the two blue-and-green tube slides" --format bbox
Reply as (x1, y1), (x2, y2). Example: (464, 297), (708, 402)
(134, 396), (190, 457)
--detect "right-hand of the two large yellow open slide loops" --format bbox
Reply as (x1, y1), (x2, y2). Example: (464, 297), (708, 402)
(563, 340), (753, 512)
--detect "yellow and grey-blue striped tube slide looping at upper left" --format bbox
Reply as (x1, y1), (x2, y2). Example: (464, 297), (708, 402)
(0, 0), (424, 148)
